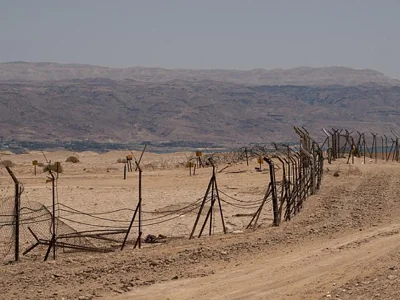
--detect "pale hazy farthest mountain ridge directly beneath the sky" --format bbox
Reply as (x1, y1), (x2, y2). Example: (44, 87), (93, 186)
(0, 62), (400, 86)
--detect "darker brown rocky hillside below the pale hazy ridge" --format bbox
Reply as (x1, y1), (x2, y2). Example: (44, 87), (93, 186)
(0, 72), (400, 150)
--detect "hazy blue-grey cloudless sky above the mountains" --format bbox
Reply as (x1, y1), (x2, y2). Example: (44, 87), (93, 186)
(0, 0), (400, 78)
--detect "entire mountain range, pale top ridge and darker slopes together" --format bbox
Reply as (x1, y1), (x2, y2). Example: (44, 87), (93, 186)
(0, 62), (400, 149)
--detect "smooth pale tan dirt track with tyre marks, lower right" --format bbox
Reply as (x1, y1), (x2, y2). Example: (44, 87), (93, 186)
(116, 224), (400, 300)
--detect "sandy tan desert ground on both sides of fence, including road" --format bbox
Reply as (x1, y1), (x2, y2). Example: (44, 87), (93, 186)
(0, 152), (400, 300)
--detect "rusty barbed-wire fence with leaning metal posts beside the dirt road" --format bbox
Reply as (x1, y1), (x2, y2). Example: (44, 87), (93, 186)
(8, 127), (390, 259)
